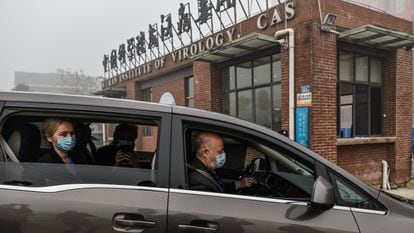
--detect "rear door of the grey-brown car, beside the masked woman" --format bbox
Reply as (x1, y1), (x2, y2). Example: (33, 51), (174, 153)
(0, 102), (170, 233)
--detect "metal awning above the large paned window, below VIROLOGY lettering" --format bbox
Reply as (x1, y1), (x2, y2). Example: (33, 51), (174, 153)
(192, 33), (278, 63)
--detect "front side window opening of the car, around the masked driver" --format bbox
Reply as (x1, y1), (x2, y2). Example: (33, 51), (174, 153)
(185, 129), (314, 201)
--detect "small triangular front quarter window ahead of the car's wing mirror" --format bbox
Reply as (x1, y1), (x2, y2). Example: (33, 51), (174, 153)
(329, 172), (384, 210)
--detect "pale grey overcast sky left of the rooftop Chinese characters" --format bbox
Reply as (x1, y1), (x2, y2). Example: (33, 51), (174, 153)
(0, 0), (190, 90)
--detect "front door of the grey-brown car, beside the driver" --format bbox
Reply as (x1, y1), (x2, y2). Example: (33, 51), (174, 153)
(168, 115), (359, 233)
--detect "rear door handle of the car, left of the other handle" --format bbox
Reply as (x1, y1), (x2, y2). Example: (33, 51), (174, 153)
(113, 214), (156, 233)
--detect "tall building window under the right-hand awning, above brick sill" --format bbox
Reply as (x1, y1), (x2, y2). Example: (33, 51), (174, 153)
(337, 51), (383, 138)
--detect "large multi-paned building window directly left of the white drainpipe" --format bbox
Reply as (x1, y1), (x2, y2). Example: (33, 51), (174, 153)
(222, 54), (281, 131)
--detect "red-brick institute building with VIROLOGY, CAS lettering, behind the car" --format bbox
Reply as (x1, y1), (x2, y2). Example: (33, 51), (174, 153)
(102, 0), (414, 184)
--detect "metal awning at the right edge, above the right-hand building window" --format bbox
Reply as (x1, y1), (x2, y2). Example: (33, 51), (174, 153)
(338, 24), (414, 50)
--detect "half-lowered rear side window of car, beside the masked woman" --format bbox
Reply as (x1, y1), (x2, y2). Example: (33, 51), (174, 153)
(0, 114), (159, 187)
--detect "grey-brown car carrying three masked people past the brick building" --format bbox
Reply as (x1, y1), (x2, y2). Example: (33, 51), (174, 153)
(0, 92), (414, 233)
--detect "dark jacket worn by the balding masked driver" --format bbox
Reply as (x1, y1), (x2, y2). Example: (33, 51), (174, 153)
(188, 158), (236, 193)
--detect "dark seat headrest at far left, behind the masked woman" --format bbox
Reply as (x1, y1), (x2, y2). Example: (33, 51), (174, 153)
(7, 123), (41, 162)
